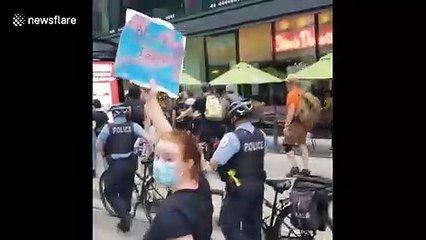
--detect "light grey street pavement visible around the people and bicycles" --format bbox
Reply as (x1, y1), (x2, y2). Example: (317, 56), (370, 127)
(93, 140), (333, 240)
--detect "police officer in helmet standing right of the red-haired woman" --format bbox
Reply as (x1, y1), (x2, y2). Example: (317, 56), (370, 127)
(210, 99), (266, 240)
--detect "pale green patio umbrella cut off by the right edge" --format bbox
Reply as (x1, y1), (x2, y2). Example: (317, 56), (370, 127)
(287, 53), (333, 80)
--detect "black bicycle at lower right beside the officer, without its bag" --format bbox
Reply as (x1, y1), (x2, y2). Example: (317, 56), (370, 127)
(262, 176), (333, 240)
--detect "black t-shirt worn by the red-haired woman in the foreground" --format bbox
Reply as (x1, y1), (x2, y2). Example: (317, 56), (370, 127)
(143, 176), (213, 240)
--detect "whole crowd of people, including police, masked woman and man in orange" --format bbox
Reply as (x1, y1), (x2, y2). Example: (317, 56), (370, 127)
(93, 79), (331, 240)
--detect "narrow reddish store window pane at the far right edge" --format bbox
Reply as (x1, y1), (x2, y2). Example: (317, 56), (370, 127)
(318, 10), (333, 57)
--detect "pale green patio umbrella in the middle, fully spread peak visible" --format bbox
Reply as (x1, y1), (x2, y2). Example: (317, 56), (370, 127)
(210, 62), (284, 86)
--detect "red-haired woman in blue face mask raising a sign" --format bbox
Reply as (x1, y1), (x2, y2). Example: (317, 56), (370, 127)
(143, 82), (213, 240)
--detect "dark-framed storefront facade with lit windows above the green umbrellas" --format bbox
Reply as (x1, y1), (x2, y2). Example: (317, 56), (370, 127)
(94, 0), (333, 104)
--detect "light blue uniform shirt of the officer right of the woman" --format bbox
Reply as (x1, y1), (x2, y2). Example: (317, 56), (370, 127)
(212, 122), (267, 166)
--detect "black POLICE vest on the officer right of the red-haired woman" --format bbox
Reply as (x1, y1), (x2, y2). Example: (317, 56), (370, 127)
(218, 128), (265, 178)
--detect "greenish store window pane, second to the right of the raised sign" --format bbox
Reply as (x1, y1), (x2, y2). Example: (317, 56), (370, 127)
(206, 33), (237, 81)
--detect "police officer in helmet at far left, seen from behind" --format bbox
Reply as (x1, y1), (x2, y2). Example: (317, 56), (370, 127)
(96, 104), (148, 232)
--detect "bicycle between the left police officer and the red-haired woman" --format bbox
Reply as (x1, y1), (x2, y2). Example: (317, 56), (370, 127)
(99, 141), (171, 223)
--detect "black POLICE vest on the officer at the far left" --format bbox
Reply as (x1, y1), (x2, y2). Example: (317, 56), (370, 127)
(104, 122), (137, 155)
